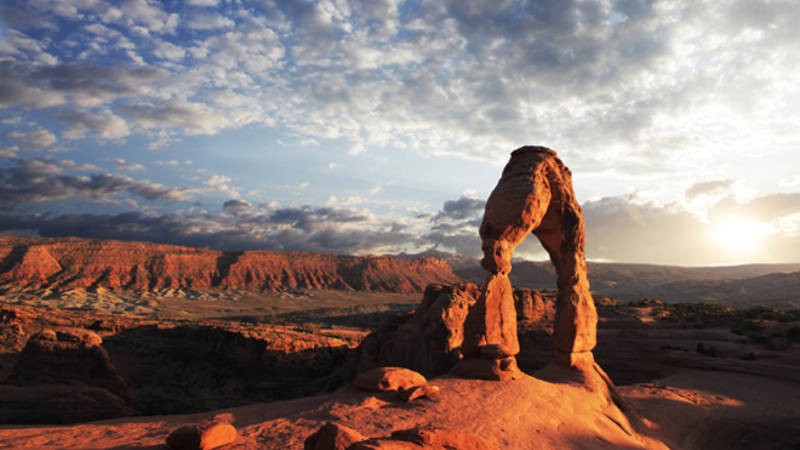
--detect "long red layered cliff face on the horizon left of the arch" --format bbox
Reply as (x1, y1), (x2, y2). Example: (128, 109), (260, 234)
(0, 236), (459, 293)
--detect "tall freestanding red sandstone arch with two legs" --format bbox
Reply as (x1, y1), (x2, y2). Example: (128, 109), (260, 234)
(460, 146), (597, 379)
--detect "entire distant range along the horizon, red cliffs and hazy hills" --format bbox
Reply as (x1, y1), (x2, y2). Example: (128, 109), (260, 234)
(0, 236), (800, 308)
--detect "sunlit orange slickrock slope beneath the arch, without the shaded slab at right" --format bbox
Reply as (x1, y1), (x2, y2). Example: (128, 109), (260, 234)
(0, 376), (676, 449)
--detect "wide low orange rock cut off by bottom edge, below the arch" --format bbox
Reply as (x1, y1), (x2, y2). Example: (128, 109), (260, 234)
(350, 427), (498, 450)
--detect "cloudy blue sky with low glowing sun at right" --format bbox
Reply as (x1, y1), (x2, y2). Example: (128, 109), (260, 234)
(0, 0), (800, 265)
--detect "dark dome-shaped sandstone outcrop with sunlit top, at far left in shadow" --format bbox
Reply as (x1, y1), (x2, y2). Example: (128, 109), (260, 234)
(8, 328), (131, 404)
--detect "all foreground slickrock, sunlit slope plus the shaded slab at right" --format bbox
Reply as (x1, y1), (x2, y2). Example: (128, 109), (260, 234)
(0, 364), (800, 449)
